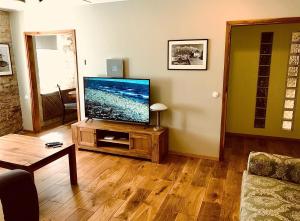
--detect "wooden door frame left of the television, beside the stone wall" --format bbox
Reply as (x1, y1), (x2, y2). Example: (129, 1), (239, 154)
(24, 29), (81, 133)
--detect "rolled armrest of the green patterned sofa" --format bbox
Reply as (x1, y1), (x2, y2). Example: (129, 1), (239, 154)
(247, 152), (300, 184)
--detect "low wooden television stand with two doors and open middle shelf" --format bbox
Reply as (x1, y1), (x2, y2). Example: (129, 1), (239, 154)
(72, 120), (168, 163)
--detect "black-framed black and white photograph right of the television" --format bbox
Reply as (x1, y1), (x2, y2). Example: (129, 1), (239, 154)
(168, 39), (208, 70)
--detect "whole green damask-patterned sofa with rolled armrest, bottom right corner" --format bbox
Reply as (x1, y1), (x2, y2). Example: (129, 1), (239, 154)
(240, 152), (300, 221)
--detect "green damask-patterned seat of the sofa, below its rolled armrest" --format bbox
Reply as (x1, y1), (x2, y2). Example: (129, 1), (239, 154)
(240, 171), (300, 221)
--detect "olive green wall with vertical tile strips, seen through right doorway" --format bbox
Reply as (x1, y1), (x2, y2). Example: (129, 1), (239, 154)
(226, 24), (300, 138)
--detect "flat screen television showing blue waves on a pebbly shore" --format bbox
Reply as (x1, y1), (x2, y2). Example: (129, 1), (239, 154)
(83, 77), (150, 124)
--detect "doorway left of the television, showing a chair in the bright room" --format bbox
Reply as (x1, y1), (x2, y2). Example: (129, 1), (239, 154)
(25, 30), (80, 133)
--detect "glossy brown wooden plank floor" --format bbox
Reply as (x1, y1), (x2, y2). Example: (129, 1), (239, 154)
(8, 126), (300, 221)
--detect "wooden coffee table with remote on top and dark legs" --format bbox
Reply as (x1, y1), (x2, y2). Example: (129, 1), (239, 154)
(0, 134), (77, 185)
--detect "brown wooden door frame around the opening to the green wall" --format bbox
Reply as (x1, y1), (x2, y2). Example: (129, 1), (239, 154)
(219, 17), (300, 160)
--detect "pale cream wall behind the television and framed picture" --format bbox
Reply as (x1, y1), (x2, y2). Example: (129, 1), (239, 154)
(11, 0), (300, 157)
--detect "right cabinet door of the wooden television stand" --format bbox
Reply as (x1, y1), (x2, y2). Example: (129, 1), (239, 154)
(130, 133), (151, 154)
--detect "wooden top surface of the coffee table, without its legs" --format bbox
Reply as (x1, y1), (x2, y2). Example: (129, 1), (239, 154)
(0, 134), (73, 166)
